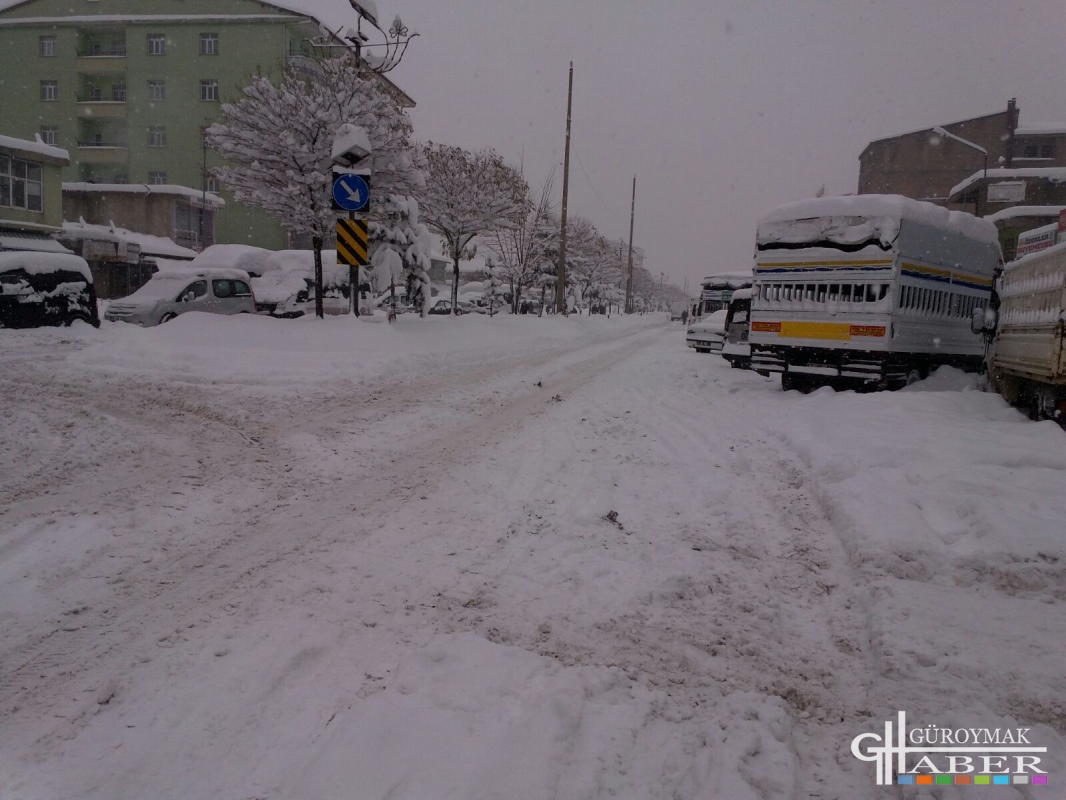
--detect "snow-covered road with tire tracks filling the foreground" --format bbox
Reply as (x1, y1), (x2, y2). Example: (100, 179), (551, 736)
(0, 315), (1066, 800)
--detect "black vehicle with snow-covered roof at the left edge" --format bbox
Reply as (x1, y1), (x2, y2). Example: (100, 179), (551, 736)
(0, 251), (100, 327)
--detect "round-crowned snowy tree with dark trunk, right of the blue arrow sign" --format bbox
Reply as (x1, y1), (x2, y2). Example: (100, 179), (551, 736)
(419, 142), (529, 314)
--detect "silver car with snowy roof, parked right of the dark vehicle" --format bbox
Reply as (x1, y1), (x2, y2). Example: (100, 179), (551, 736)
(103, 269), (256, 327)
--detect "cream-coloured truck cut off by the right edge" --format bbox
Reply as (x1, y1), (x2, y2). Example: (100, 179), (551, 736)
(972, 237), (1066, 426)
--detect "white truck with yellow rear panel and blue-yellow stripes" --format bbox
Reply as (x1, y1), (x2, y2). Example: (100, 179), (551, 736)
(749, 194), (1002, 390)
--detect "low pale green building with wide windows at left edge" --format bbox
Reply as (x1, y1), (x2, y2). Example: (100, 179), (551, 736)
(0, 133), (70, 253)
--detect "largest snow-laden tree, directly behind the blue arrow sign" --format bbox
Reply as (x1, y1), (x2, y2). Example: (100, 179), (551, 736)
(206, 54), (423, 315)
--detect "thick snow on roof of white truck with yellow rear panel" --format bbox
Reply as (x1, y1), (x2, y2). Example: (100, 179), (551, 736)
(757, 193), (999, 244)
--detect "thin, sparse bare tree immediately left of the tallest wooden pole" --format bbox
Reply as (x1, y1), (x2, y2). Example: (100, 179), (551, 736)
(489, 174), (559, 314)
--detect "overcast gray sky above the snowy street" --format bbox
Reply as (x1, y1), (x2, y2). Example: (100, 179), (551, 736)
(303, 0), (1066, 288)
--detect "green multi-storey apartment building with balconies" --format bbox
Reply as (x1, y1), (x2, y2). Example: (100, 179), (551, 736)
(0, 0), (413, 250)
